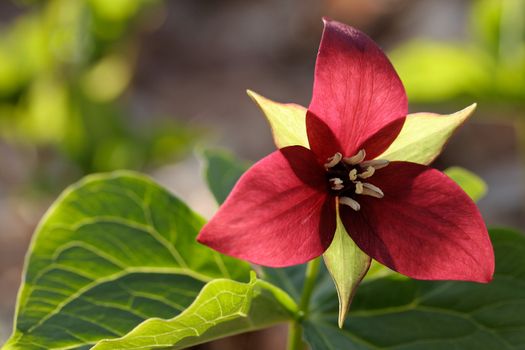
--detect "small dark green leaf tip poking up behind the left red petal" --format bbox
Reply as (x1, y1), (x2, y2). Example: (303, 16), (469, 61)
(203, 149), (249, 204)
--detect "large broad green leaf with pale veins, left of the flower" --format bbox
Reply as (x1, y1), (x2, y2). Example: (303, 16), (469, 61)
(5, 172), (250, 349)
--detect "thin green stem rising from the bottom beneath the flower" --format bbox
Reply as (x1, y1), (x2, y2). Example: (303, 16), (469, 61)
(287, 257), (321, 350)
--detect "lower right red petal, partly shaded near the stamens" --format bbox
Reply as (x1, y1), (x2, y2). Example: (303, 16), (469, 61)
(341, 162), (494, 282)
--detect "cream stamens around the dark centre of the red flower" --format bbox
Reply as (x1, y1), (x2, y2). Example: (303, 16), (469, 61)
(324, 149), (388, 211)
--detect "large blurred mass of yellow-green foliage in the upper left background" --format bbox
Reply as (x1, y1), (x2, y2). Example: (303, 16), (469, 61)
(0, 0), (198, 190)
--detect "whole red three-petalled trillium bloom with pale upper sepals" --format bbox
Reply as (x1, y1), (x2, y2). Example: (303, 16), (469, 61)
(198, 20), (494, 282)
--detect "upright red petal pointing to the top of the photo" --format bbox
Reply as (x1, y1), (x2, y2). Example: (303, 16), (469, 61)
(308, 19), (408, 159)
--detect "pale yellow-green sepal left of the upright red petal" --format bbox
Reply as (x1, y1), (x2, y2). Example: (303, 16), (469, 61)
(246, 90), (310, 148)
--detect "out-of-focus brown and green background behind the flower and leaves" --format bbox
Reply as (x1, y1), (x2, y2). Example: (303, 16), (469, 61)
(0, 0), (525, 350)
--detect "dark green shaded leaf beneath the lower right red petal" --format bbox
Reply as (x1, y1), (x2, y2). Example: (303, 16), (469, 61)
(304, 229), (525, 350)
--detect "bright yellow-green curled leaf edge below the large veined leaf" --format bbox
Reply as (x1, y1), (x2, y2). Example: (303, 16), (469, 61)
(93, 278), (298, 350)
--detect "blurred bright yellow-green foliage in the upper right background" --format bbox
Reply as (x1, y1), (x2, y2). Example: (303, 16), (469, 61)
(390, 0), (525, 106)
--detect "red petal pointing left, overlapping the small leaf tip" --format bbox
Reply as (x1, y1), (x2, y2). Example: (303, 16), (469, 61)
(197, 146), (336, 267)
